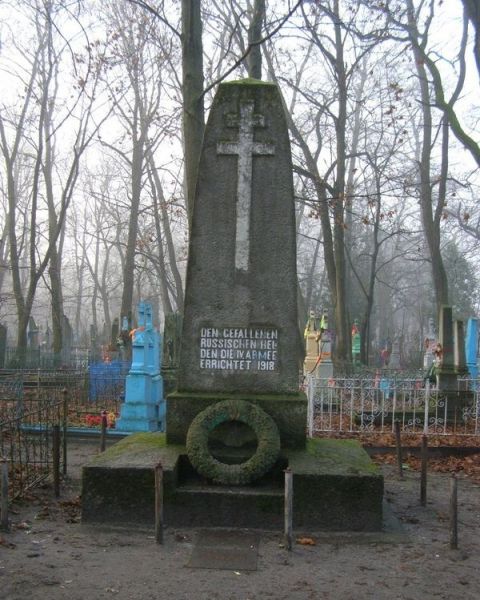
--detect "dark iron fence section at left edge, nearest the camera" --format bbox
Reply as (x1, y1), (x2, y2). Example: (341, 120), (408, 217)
(0, 397), (66, 500)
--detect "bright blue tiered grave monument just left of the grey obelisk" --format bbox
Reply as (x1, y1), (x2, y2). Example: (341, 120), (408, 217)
(115, 302), (165, 431)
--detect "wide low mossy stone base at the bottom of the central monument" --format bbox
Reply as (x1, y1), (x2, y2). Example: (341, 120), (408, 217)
(82, 433), (383, 531)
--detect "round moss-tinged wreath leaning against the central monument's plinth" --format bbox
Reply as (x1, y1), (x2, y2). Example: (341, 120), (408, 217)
(187, 400), (280, 485)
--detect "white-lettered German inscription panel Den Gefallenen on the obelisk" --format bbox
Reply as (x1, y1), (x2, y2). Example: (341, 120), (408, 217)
(200, 327), (278, 371)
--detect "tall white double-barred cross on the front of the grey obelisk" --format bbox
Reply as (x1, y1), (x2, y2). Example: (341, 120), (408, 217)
(217, 102), (275, 271)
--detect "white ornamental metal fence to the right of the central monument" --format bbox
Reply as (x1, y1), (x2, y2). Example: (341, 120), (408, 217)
(306, 376), (480, 437)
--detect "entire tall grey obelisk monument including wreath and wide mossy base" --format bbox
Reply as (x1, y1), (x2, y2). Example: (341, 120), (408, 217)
(82, 79), (383, 531)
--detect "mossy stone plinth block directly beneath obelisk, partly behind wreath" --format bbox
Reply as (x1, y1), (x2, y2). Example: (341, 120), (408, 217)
(167, 392), (307, 448)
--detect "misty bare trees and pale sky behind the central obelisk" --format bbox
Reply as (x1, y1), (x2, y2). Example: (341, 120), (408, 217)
(0, 0), (480, 364)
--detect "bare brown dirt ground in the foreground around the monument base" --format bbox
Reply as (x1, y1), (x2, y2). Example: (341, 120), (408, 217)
(0, 441), (480, 600)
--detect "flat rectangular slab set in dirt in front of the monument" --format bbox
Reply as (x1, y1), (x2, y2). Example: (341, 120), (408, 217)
(186, 529), (259, 571)
